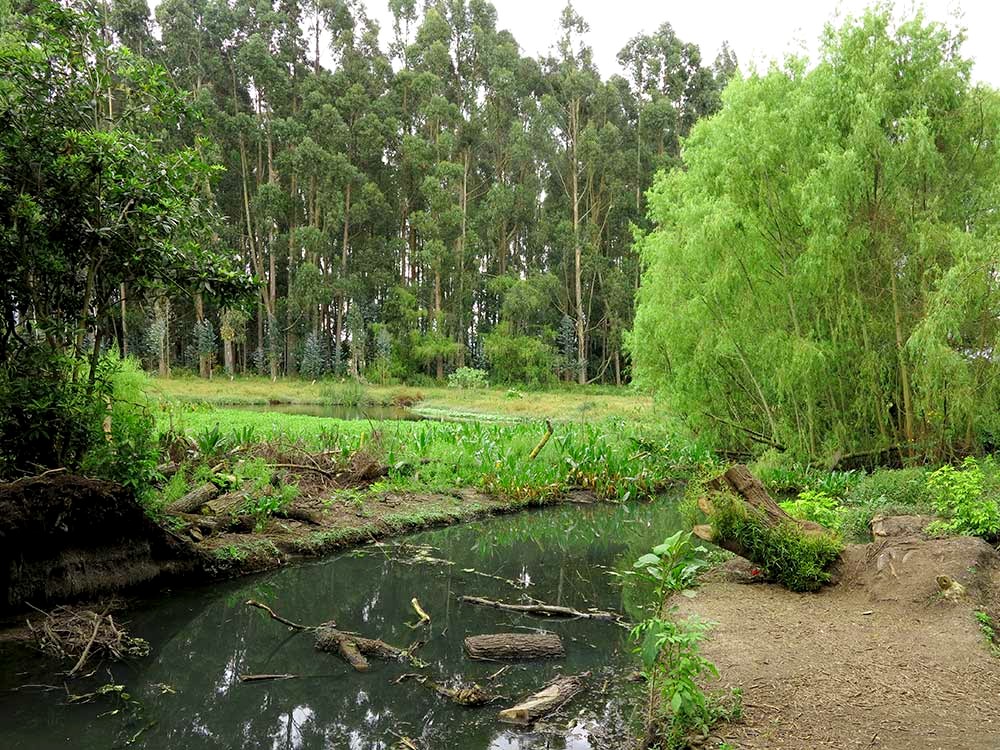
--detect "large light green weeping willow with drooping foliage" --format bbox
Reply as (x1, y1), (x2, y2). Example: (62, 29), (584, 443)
(630, 8), (1000, 458)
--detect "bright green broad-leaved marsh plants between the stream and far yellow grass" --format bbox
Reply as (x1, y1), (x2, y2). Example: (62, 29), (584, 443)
(159, 407), (707, 503)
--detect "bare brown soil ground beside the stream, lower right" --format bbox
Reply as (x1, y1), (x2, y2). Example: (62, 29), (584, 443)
(678, 529), (1000, 750)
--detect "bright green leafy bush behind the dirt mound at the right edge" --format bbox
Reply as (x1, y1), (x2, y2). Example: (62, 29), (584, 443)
(927, 456), (1000, 538)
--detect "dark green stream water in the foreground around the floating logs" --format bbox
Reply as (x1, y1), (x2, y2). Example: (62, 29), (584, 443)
(0, 499), (677, 750)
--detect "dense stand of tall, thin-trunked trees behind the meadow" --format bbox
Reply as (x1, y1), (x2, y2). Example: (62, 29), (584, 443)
(3, 0), (736, 384)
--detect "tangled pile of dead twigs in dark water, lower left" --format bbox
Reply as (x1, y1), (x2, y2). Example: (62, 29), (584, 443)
(28, 606), (149, 676)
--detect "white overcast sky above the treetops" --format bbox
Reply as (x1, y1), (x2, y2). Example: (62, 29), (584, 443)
(365, 0), (1000, 87)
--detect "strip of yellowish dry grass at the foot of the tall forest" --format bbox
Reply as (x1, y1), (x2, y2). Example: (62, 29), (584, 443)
(150, 377), (657, 422)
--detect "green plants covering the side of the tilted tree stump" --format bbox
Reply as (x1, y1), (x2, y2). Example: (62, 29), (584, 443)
(712, 494), (843, 591)
